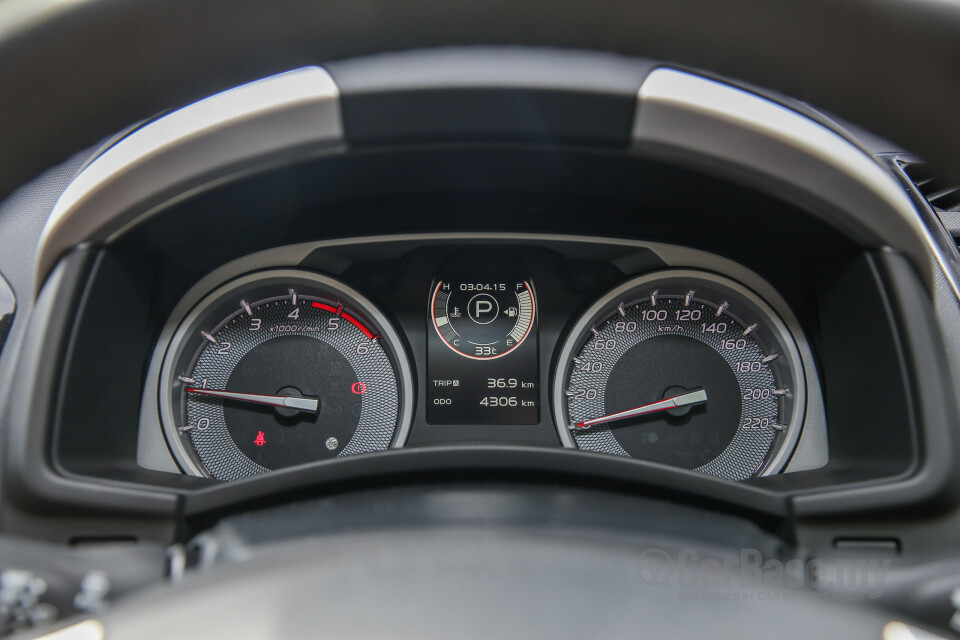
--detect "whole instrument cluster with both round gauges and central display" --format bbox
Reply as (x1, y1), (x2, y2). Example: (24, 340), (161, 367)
(146, 239), (810, 481)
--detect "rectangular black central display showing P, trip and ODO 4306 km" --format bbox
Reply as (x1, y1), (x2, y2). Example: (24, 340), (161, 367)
(427, 277), (540, 424)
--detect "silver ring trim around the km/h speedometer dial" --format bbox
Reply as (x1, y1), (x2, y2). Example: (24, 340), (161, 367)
(552, 269), (807, 476)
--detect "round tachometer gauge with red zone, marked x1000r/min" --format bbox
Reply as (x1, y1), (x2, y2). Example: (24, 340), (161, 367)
(160, 270), (412, 480)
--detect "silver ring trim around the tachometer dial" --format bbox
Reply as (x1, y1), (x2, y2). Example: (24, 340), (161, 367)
(153, 269), (414, 477)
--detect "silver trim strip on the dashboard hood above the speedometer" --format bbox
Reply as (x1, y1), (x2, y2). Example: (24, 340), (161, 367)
(632, 68), (960, 296)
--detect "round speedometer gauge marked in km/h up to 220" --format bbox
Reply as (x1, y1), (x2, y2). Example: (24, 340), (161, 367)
(554, 270), (805, 480)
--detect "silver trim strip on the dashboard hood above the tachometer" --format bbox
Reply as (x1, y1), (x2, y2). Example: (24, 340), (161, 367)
(36, 67), (344, 291)
